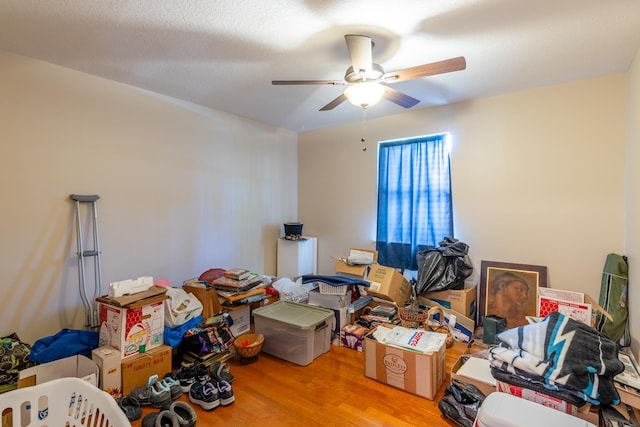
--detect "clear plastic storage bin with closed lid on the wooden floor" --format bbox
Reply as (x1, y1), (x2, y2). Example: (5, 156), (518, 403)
(253, 300), (335, 366)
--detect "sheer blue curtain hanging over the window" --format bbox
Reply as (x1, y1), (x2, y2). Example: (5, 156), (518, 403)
(376, 135), (453, 270)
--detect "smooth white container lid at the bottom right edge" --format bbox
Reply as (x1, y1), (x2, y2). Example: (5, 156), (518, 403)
(473, 392), (596, 427)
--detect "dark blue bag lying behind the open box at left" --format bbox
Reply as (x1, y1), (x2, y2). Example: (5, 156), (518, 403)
(29, 329), (100, 363)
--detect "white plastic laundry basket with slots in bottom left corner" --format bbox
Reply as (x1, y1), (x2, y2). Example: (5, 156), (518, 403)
(0, 378), (131, 427)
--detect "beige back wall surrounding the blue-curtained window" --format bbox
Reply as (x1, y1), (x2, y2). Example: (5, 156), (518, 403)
(298, 74), (627, 304)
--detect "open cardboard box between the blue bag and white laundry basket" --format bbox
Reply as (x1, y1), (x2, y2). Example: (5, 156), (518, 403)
(18, 355), (100, 388)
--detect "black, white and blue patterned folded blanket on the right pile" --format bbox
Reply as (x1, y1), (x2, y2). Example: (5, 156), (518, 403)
(489, 312), (624, 405)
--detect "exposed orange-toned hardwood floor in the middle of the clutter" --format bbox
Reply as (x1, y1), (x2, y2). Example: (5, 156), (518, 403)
(132, 343), (465, 427)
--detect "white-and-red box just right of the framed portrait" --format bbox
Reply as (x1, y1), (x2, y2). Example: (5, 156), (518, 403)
(538, 288), (595, 326)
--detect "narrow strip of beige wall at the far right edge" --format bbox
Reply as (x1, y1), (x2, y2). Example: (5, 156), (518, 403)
(625, 47), (640, 357)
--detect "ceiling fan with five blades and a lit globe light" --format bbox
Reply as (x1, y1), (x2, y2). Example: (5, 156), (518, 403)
(271, 34), (467, 111)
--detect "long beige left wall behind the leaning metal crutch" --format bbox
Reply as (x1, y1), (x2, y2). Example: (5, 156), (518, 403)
(0, 51), (297, 342)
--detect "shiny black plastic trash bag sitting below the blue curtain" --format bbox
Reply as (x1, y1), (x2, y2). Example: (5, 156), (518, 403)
(415, 237), (473, 295)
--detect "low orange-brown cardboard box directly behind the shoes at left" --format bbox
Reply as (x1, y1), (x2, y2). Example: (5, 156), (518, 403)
(121, 345), (172, 396)
